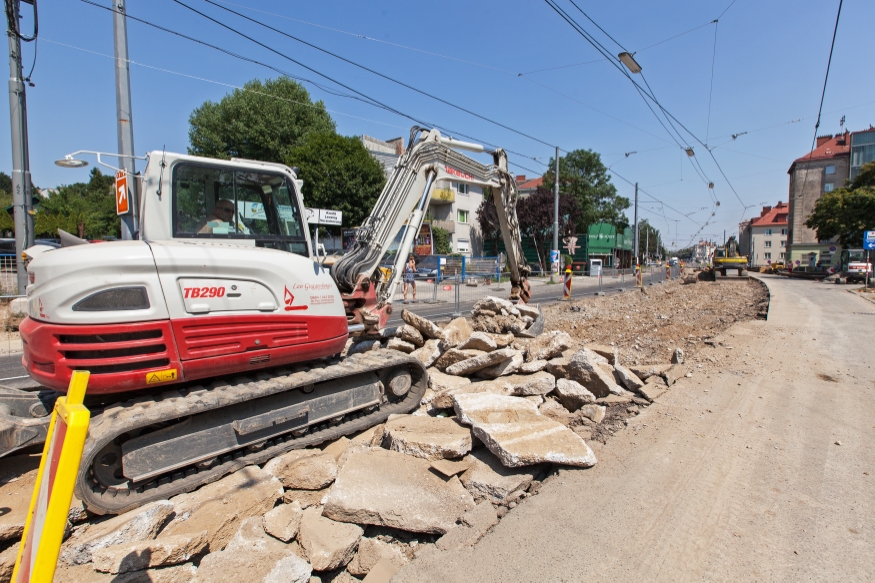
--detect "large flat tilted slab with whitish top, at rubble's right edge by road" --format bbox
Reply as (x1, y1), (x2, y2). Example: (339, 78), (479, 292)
(453, 394), (596, 467)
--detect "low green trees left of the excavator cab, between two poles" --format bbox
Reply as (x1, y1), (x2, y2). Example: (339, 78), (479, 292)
(34, 168), (120, 239)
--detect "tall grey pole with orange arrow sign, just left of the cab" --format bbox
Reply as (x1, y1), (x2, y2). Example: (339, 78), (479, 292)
(112, 0), (140, 239)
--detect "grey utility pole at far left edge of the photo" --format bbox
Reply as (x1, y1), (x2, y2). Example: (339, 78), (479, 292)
(6, 0), (36, 295)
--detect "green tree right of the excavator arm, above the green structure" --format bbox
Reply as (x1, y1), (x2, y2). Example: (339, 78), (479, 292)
(544, 150), (630, 233)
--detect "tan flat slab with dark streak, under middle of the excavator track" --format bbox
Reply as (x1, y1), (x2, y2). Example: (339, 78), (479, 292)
(161, 466), (283, 551)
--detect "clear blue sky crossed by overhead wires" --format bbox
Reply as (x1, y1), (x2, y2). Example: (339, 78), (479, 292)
(0, 0), (875, 246)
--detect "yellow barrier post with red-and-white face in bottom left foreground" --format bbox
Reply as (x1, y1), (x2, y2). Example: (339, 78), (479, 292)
(12, 371), (91, 583)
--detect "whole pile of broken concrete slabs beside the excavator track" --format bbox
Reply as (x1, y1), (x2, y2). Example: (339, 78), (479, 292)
(0, 297), (685, 583)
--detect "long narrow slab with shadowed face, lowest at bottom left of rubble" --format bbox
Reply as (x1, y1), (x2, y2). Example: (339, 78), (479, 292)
(91, 530), (208, 574)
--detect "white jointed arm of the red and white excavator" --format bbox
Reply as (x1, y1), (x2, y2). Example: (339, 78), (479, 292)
(332, 127), (530, 330)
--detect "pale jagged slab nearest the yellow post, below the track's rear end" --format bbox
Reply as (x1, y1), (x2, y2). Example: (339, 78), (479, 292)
(59, 500), (174, 565)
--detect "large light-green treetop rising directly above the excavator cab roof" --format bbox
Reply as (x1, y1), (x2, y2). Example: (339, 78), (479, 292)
(188, 77), (335, 163)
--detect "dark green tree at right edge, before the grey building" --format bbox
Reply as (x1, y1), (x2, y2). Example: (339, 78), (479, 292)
(805, 162), (875, 249)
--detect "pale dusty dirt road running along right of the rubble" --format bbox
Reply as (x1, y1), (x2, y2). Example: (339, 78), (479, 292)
(393, 276), (875, 582)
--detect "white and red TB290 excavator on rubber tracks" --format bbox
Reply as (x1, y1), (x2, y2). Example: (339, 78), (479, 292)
(0, 127), (543, 514)
